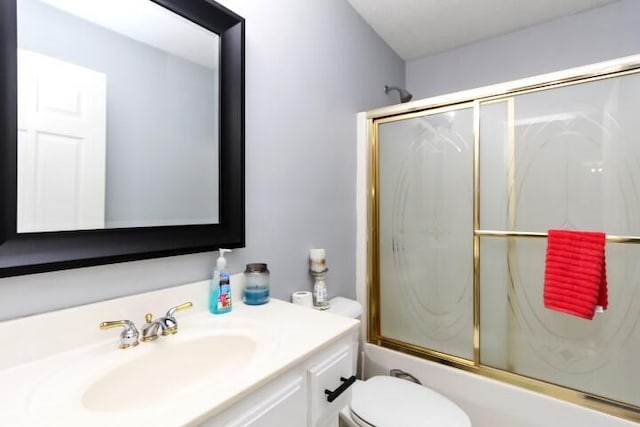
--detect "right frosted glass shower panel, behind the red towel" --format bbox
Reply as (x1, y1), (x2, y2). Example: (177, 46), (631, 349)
(479, 74), (640, 406)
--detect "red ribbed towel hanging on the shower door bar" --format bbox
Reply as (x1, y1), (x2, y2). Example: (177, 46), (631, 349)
(544, 230), (608, 319)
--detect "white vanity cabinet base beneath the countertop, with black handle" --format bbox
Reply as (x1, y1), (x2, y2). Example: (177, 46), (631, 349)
(200, 333), (357, 427)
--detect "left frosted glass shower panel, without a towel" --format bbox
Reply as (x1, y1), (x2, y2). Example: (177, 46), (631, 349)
(378, 105), (473, 359)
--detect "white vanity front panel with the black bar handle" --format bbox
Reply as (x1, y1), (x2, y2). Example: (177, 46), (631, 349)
(307, 345), (355, 427)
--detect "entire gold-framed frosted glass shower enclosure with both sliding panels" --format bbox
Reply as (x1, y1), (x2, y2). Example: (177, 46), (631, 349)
(369, 56), (640, 421)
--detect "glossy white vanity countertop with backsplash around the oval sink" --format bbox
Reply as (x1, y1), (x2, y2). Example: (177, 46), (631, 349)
(0, 275), (359, 426)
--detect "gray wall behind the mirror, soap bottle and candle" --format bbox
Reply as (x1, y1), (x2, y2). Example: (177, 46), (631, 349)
(0, 0), (404, 319)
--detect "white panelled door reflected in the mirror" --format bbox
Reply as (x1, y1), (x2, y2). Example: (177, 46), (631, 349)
(17, 50), (107, 233)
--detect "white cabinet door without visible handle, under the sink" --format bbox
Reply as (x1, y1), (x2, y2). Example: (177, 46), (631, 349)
(202, 375), (307, 427)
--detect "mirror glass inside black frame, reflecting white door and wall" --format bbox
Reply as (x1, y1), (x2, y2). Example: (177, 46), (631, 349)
(17, 0), (219, 233)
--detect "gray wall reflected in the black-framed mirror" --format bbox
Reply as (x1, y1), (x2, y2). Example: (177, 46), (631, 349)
(18, 0), (218, 227)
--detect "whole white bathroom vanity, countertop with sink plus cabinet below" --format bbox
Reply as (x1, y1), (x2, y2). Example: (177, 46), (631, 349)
(0, 280), (359, 427)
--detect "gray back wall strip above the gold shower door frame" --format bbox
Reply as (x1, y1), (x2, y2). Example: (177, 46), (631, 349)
(406, 0), (640, 99)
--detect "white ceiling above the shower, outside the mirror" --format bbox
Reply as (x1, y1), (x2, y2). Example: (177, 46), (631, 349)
(348, 0), (618, 60)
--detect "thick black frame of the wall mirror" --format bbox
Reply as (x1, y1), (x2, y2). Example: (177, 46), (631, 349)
(0, 0), (245, 277)
